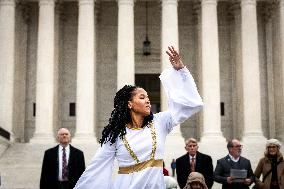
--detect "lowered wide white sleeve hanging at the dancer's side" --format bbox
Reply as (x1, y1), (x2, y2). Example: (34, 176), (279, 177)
(74, 142), (116, 189)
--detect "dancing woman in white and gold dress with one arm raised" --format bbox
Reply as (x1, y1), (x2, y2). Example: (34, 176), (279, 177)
(75, 47), (203, 189)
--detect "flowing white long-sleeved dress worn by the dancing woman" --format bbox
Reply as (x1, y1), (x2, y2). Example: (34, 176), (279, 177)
(75, 67), (203, 189)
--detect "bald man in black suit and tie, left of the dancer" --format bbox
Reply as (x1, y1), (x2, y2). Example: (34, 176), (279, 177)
(40, 128), (85, 189)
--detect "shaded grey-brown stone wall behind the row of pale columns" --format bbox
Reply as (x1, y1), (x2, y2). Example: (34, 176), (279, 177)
(9, 1), (283, 141)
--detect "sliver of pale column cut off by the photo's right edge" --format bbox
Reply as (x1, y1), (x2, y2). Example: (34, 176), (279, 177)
(279, 0), (284, 141)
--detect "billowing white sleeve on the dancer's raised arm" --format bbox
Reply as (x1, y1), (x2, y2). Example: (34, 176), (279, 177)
(160, 67), (203, 125)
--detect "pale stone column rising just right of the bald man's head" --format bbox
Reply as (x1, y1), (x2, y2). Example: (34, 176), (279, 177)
(75, 0), (95, 141)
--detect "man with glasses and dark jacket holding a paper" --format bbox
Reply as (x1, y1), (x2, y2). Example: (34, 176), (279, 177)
(214, 139), (254, 189)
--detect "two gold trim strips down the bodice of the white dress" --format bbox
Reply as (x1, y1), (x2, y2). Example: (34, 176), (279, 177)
(122, 121), (157, 163)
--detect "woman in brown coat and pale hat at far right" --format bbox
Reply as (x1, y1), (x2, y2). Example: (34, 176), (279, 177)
(254, 139), (284, 189)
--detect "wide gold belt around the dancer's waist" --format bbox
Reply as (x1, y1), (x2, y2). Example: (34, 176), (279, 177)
(118, 159), (163, 174)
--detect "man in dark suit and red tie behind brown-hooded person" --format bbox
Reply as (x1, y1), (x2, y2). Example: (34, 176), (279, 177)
(176, 138), (213, 189)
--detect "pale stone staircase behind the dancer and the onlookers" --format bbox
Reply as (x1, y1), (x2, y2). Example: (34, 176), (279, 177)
(0, 139), (284, 189)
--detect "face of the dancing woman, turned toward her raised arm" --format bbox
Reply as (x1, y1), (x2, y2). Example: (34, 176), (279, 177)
(128, 88), (151, 116)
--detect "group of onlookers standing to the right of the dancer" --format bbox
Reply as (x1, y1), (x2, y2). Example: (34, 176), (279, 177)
(164, 138), (284, 189)
